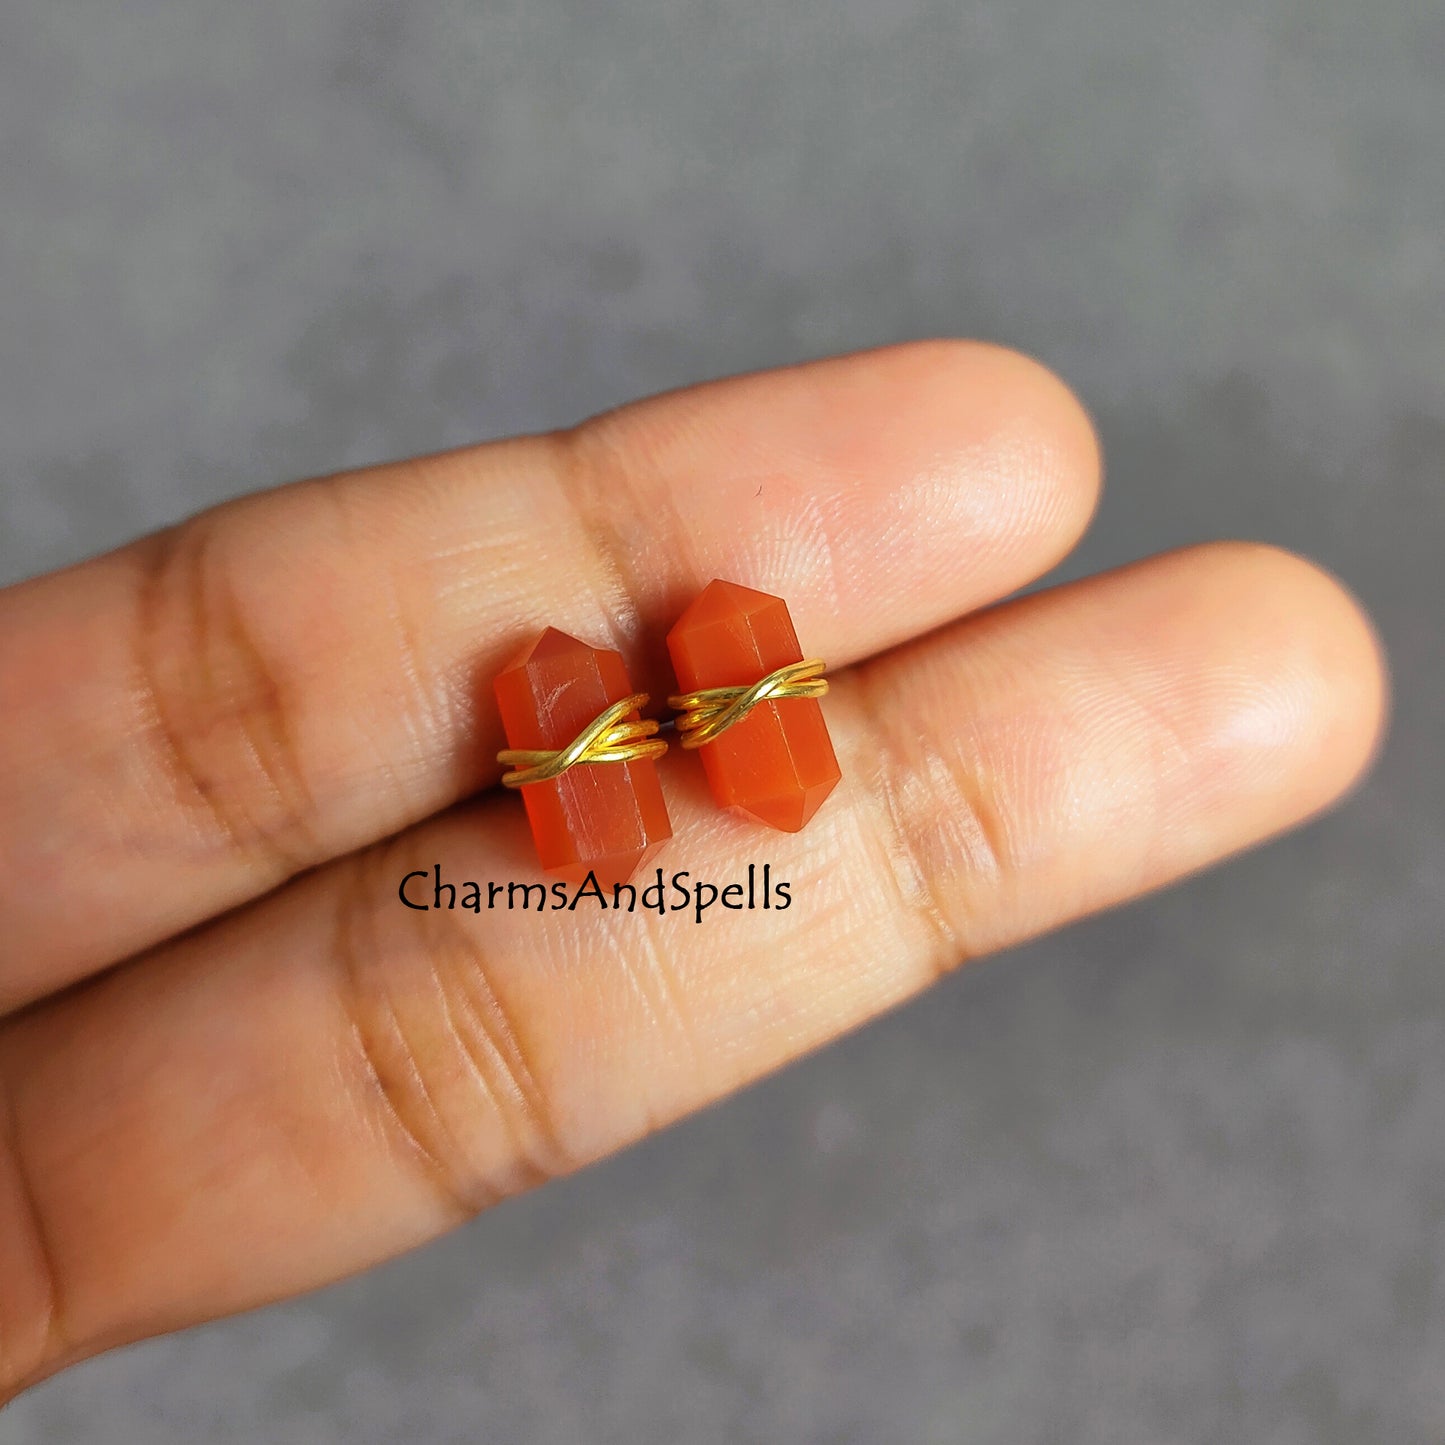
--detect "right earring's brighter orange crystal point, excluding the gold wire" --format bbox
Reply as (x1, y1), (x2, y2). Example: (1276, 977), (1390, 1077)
(668, 582), (842, 832)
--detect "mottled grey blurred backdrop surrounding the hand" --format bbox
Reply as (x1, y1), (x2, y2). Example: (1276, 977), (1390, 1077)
(0, 0), (1445, 1445)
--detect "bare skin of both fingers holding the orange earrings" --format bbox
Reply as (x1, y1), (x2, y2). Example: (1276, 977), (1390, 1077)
(0, 341), (1384, 1396)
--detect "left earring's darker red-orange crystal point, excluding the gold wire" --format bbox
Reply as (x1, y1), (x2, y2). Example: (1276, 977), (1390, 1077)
(493, 627), (672, 889)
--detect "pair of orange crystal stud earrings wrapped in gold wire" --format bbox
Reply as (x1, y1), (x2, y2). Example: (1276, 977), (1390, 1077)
(494, 581), (841, 887)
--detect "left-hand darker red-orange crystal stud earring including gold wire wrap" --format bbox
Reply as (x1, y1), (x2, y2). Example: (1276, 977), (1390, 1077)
(493, 627), (672, 887)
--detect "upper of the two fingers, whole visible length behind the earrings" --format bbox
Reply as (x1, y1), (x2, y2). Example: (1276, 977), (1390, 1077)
(0, 342), (1098, 1009)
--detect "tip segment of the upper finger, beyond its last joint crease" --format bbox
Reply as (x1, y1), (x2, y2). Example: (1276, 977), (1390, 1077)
(565, 338), (1100, 665)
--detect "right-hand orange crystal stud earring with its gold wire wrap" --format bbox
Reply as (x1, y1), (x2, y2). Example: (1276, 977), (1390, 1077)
(668, 581), (842, 832)
